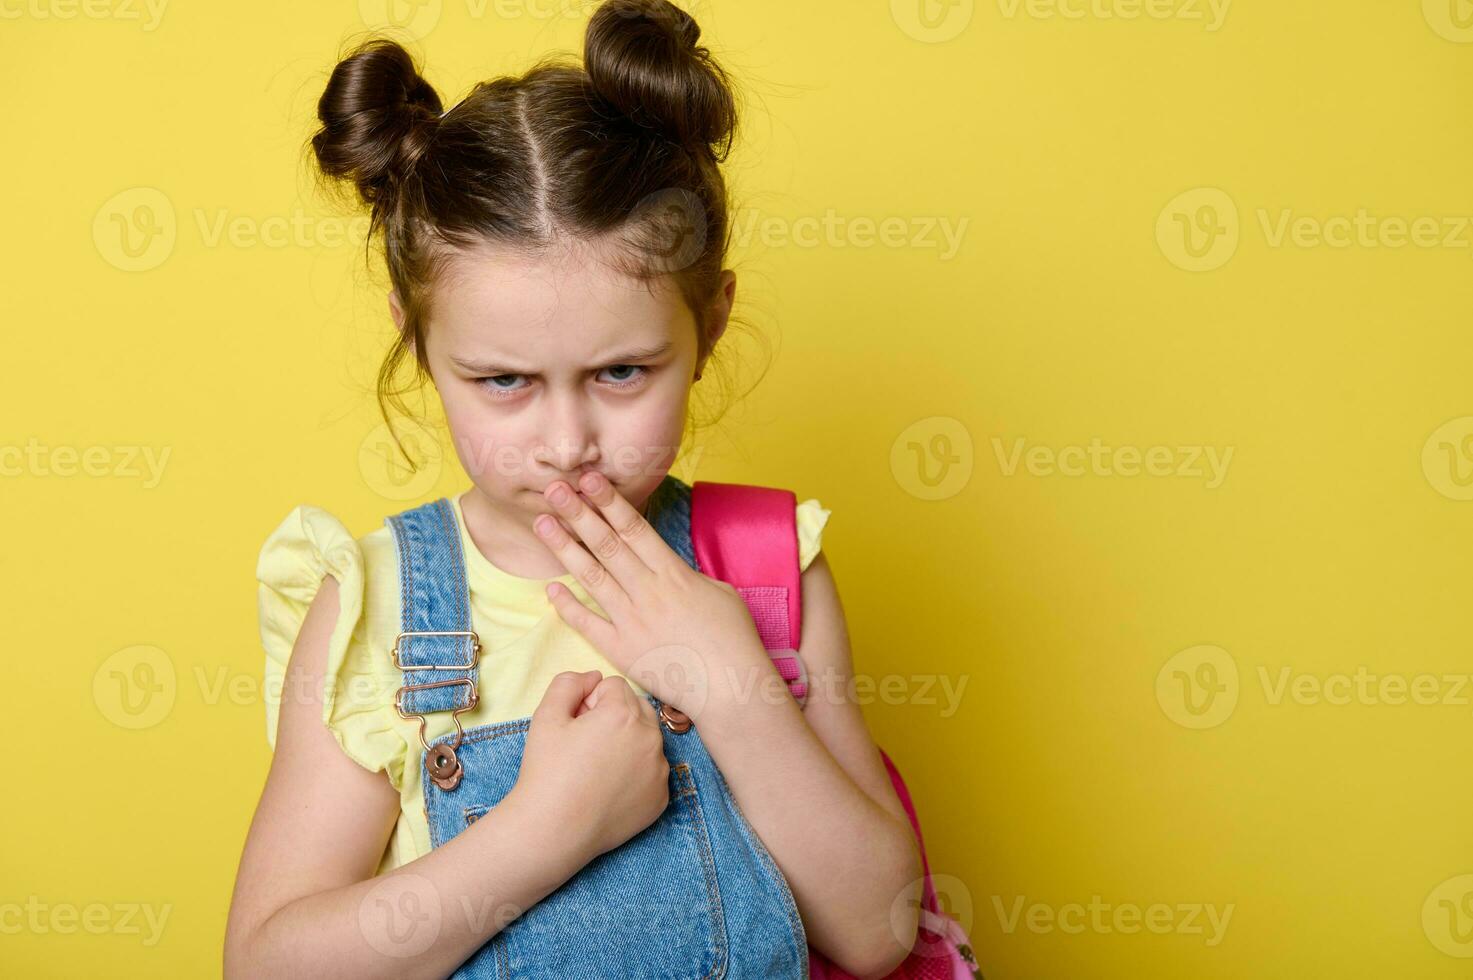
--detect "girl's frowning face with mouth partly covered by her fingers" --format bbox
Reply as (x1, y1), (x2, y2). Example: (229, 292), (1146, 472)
(390, 237), (735, 554)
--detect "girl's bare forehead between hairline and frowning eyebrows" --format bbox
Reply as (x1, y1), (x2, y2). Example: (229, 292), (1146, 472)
(430, 241), (694, 358)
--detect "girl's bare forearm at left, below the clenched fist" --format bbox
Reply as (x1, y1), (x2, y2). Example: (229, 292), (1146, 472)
(224, 788), (594, 980)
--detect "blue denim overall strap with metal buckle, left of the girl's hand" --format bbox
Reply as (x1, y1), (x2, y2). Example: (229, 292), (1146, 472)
(384, 497), (480, 778)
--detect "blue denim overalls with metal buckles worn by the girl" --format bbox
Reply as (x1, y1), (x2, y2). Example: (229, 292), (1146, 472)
(386, 476), (809, 980)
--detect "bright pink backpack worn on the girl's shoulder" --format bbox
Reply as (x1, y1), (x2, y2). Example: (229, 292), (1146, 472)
(691, 480), (982, 980)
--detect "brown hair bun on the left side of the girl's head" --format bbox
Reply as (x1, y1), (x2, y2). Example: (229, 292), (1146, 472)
(312, 38), (440, 203)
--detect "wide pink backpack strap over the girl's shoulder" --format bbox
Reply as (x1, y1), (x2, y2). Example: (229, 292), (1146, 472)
(691, 480), (809, 704)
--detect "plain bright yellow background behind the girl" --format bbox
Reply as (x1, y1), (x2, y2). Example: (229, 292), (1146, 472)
(0, 0), (1473, 980)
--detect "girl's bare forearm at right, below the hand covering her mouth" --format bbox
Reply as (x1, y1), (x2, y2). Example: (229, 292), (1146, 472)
(700, 680), (921, 977)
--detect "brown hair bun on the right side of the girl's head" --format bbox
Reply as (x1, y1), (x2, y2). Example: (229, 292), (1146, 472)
(583, 0), (737, 158)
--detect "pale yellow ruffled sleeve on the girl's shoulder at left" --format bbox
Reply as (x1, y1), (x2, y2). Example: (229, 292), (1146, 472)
(256, 504), (404, 785)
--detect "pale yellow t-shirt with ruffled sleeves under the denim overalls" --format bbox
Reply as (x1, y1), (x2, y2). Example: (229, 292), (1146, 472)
(256, 494), (829, 874)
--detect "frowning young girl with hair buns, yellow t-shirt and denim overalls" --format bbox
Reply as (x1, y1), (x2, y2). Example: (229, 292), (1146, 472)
(224, 0), (922, 979)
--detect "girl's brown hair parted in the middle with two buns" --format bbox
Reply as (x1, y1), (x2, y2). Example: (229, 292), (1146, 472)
(309, 0), (754, 467)
